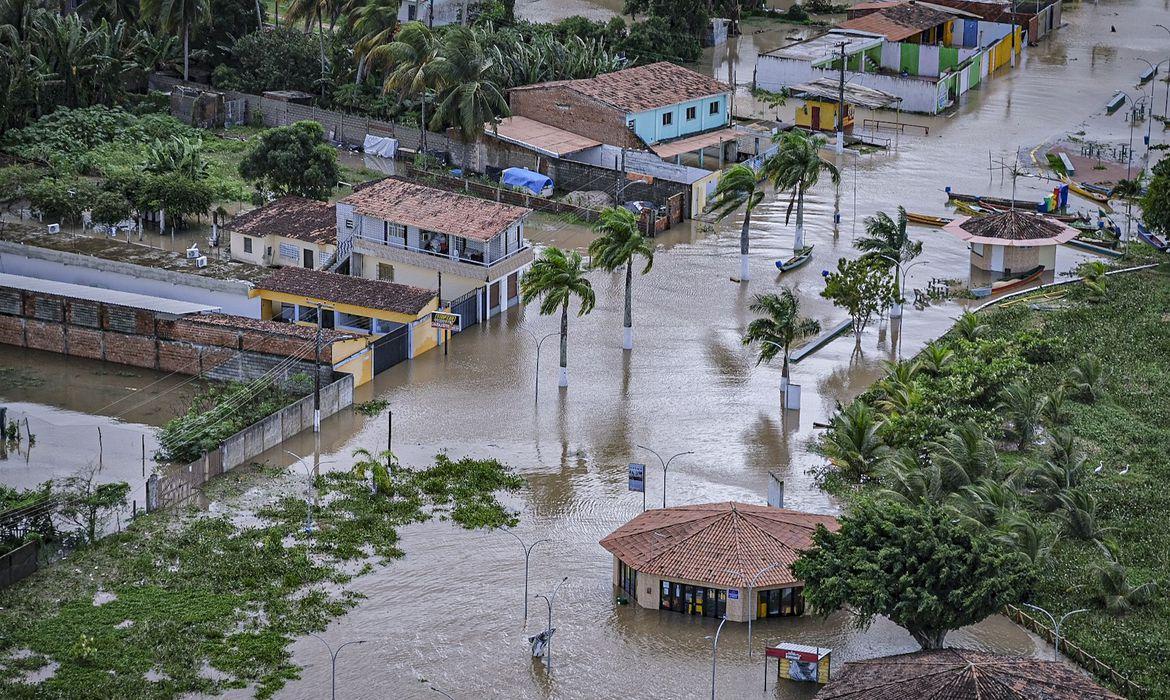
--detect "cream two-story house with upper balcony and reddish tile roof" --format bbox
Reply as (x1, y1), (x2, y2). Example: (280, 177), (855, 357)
(337, 178), (532, 328)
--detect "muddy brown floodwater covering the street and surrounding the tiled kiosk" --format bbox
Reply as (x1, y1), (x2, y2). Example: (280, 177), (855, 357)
(265, 1), (1170, 699)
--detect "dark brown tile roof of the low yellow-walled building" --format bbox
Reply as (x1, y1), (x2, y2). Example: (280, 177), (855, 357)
(256, 267), (435, 316)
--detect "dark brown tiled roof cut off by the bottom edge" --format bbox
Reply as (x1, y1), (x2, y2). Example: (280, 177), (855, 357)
(817, 648), (1121, 700)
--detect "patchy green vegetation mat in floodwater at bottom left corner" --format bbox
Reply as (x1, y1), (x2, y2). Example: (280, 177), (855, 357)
(0, 455), (523, 699)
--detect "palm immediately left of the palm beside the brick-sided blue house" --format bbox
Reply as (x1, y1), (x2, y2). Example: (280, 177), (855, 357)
(369, 22), (439, 152)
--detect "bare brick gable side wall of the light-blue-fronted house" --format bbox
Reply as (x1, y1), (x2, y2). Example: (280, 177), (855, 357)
(508, 85), (646, 149)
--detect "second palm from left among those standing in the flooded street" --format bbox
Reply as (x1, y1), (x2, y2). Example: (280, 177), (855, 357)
(519, 248), (597, 386)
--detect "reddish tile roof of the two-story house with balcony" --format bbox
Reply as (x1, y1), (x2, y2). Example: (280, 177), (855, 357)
(342, 178), (531, 241)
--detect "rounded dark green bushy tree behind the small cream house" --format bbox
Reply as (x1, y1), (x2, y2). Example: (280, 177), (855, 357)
(240, 122), (339, 199)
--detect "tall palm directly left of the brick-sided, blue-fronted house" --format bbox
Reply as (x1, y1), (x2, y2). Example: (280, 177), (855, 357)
(431, 26), (511, 172)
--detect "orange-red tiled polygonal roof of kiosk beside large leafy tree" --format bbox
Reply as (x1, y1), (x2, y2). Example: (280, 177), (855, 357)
(601, 501), (839, 588)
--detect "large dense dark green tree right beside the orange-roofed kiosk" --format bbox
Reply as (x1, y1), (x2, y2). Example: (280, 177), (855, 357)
(793, 500), (1035, 648)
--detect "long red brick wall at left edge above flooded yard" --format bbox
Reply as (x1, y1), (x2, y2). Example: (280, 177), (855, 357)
(0, 282), (332, 383)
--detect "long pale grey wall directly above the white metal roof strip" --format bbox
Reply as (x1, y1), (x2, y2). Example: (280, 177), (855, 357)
(0, 241), (260, 318)
